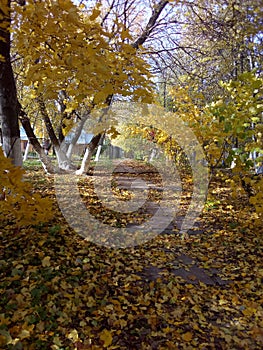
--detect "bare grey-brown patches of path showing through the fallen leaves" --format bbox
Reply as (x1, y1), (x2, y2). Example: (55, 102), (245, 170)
(97, 160), (231, 286)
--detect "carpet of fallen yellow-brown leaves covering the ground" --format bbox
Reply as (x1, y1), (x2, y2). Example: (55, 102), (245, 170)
(0, 161), (263, 350)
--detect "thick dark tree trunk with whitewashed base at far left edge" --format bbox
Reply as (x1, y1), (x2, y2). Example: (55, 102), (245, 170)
(0, 0), (22, 166)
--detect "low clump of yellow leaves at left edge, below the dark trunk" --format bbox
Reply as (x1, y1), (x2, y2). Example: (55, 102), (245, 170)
(0, 149), (53, 226)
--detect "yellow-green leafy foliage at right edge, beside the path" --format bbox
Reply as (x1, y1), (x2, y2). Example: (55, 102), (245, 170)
(169, 78), (263, 222)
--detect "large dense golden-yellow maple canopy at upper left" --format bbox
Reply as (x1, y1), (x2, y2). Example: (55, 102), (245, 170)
(13, 0), (152, 111)
